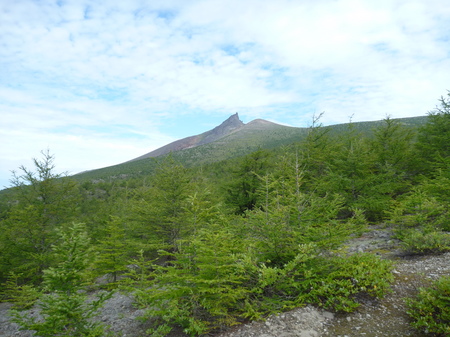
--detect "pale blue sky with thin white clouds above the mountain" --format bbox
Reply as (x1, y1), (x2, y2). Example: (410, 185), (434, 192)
(0, 0), (450, 189)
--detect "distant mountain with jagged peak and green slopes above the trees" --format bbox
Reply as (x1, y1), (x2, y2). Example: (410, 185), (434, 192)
(76, 113), (427, 180)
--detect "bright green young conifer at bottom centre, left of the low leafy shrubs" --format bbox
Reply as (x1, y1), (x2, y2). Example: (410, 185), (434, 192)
(139, 229), (247, 336)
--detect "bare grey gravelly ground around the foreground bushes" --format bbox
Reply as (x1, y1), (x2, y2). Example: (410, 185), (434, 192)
(0, 227), (450, 337)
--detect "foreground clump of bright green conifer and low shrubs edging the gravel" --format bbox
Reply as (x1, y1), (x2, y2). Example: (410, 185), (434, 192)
(137, 234), (392, 337)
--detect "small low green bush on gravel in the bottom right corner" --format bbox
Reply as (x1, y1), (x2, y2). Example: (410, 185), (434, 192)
(407, 276), (450, 336)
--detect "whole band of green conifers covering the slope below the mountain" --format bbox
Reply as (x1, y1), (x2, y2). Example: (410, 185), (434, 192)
(0, 94), (450, 336)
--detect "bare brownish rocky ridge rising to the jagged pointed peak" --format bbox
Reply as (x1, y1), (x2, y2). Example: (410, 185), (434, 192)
(130, 113), (245, 161)
